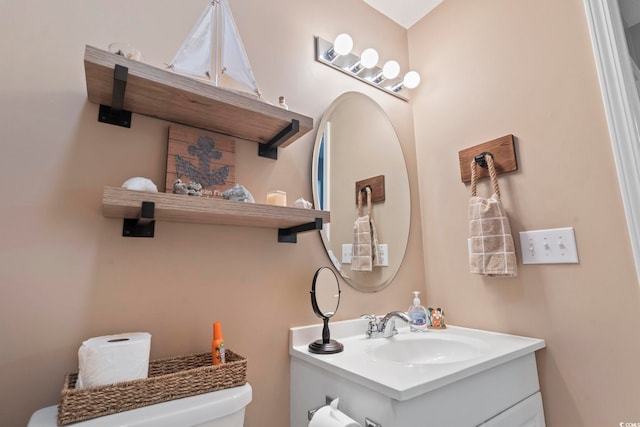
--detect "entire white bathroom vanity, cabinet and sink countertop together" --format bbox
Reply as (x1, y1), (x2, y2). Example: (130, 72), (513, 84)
(289, 319), (544, 427)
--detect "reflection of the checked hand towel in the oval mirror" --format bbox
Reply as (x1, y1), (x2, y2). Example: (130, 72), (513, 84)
(351, 187), (379, 271)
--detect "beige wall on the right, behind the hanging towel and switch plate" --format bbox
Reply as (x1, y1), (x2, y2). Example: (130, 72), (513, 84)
(409, 0), (640, 427)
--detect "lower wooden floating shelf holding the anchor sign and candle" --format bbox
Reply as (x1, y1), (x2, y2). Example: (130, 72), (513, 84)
(102, 187), (330, 242)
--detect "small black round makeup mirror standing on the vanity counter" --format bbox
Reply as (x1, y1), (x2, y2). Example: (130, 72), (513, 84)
(309, 267), (344, 354)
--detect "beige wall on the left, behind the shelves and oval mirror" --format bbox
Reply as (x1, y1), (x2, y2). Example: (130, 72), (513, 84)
(0, 0), (425, 427)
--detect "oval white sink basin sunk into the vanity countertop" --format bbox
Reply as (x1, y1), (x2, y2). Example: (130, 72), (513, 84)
(366, 332), (490, 366)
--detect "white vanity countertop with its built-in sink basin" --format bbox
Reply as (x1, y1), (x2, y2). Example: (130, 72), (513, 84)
(289, 319), (544, 401)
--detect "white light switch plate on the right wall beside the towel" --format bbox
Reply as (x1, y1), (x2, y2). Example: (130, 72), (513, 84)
(520, 227), (579, 264)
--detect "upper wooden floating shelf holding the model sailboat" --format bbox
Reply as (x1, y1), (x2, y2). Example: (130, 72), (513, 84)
(84, 45), (313, 152)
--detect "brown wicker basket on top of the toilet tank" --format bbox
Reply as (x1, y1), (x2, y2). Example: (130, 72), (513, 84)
(58, 349), (247, 426)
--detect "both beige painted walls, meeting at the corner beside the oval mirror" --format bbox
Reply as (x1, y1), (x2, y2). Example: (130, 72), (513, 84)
(5, 0), (640, 427)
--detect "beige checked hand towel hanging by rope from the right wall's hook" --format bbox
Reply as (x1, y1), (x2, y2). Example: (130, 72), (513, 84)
(469, 153), (518, 277)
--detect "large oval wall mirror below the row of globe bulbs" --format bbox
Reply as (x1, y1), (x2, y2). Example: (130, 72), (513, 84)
(312, 92), (411, 292)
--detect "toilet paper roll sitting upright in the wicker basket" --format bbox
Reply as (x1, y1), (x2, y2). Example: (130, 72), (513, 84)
(76, 332), (151, 388)
